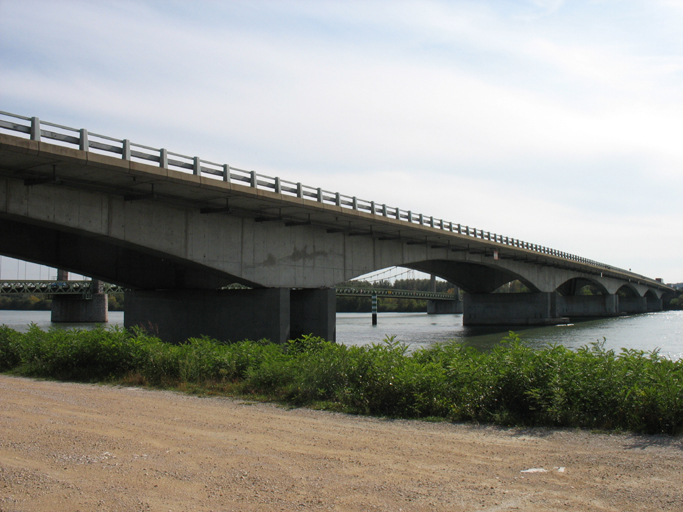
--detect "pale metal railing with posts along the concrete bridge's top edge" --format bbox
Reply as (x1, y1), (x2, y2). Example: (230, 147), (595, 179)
(0, 111), (664, 282)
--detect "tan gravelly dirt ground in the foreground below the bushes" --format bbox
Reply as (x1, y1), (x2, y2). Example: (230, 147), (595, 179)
(0, 376), (683, 512)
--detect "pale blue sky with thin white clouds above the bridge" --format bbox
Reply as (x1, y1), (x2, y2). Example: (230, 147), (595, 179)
(0, 0), (683, 283)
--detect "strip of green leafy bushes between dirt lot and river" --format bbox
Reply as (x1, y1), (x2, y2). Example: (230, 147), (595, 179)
(0, 326), (683, 435)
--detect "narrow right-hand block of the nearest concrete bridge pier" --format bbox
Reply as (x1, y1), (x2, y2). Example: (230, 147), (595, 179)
(289, 288), (337, 341)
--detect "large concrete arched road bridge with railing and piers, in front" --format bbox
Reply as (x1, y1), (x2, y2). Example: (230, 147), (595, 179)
(0, 112), (673, 341)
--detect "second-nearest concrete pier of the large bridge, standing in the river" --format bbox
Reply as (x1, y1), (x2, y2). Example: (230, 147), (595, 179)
(462, 292), (569, 326)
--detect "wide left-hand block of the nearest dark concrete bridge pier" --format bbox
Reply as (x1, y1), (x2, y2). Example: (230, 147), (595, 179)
(124, 288), (290, 343)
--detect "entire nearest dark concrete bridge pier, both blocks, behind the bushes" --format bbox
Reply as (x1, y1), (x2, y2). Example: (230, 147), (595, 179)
(124, 288), (335, 343)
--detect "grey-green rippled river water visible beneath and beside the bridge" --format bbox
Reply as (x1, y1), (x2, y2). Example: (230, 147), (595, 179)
(0, 311), (683, 359)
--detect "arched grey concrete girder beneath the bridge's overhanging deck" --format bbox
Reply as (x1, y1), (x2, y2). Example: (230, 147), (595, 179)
(0, 175), (662, 304)
